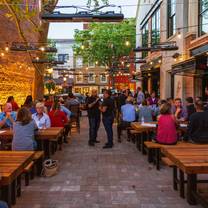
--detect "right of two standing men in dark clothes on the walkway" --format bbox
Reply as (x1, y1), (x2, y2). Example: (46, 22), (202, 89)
(99, 90), (114, 149)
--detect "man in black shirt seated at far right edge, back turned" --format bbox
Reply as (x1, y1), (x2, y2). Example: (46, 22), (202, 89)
(187, 101), (208, 143)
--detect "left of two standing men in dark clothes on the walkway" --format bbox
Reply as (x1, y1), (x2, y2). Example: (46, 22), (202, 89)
(86, 90), (100, 146)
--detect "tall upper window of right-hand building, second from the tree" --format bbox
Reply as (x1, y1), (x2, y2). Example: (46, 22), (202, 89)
(151, 9), (160, 45)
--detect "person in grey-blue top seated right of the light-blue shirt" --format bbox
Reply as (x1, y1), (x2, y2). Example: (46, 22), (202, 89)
(139, 100), (152, 122)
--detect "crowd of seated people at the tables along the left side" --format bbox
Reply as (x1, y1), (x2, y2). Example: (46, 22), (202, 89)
(0, 93), (82, 150)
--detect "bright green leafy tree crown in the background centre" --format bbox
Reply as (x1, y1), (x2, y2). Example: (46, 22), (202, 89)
(73, 19), (136, 67)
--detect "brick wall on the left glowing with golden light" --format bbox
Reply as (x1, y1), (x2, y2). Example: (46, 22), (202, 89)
(0, 0), (47, 105)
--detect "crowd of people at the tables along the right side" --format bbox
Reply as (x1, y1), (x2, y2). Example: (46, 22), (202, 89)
(116, 87), (208, 144)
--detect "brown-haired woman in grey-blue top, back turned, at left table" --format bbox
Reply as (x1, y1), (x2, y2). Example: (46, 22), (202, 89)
(12, 107), (38, 151)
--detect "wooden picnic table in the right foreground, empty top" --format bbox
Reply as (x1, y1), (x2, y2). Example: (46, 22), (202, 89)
(161, 144), (208, 207)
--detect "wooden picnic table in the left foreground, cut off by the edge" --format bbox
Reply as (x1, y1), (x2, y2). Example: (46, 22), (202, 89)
(0, 151), (35, 207)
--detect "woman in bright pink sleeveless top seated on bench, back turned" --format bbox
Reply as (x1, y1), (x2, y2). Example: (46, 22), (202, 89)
(156, 103), (177, 144)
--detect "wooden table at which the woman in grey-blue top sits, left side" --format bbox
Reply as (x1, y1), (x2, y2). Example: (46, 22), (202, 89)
(0, 127), (64, 157)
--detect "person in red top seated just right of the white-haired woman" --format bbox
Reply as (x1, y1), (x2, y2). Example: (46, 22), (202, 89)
(48, 102), (68, 127)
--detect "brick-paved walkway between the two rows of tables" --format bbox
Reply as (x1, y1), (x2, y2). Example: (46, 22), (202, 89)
(14, 118), (202, 208)
